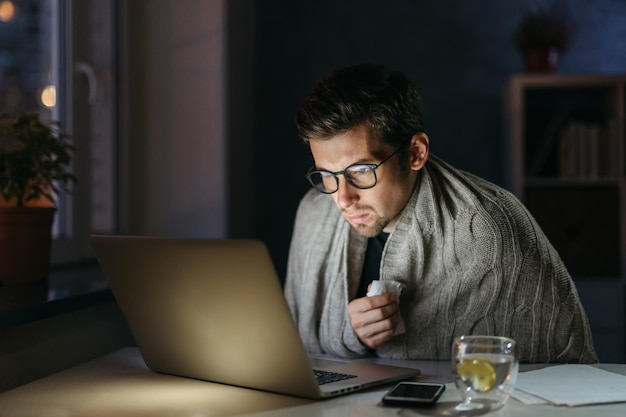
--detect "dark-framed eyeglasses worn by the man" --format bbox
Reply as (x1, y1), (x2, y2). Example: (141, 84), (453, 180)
(305, 147), (402, 194)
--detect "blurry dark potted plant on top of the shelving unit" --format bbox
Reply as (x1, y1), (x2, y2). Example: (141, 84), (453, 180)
(514, 5), (574, 72)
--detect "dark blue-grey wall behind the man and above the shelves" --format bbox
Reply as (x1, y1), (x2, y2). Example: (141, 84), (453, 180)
(256, 0), (626, 277)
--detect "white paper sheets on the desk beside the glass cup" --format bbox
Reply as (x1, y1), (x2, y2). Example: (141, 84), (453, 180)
(512, 365), (626, 406)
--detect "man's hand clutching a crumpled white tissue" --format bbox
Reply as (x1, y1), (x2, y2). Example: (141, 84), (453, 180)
(348, 293), (399, 349)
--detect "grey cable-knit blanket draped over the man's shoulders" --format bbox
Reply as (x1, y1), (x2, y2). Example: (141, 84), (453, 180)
(285, 154), (597, 363)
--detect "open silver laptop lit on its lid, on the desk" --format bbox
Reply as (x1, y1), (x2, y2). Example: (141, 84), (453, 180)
(90, 236), (420, 400)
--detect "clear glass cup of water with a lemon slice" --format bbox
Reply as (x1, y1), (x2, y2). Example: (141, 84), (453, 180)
(452, 336), (518, 411)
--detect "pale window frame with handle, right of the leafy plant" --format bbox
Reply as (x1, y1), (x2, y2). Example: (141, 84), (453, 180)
(50, 0), (119, 267)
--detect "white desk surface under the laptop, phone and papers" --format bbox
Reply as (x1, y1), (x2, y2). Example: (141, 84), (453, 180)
(0, 348), (626, 417)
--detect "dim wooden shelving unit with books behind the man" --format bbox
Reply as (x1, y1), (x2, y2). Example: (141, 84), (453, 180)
(506, 74), (626, 363)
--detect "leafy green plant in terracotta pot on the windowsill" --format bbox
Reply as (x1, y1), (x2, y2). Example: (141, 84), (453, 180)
(0, 110), (76, 284)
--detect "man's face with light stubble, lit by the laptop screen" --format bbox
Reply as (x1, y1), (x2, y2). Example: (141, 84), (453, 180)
(309, 126), (427, 237)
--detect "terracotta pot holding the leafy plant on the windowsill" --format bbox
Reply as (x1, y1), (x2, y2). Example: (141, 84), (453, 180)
(0, 207), (55, 285)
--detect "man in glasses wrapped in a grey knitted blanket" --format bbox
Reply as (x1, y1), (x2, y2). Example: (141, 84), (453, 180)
(285, 65), (597, 363)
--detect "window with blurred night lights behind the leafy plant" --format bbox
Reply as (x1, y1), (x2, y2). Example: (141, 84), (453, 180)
(0, 0), (117, 264)
